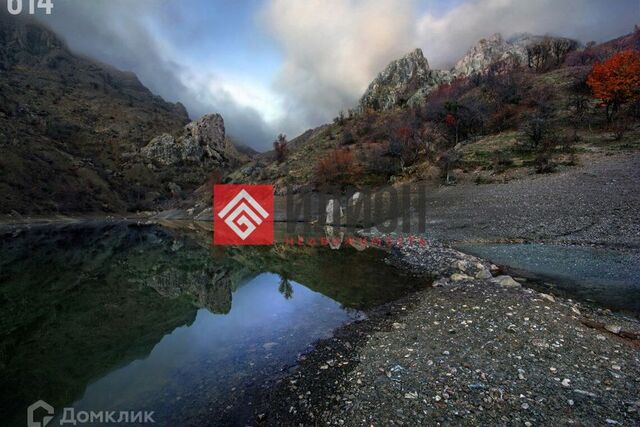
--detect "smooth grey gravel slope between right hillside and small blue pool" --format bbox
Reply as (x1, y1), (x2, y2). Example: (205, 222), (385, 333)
(416, 153), (640, 248)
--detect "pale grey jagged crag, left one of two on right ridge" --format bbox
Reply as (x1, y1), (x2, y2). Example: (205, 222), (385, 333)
(360, 49), (452, 110)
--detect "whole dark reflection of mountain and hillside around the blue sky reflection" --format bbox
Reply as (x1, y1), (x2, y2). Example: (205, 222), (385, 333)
(0, 222), (420, 425)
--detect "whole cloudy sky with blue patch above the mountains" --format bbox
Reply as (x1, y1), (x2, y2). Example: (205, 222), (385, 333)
(33, 0), (640, 151)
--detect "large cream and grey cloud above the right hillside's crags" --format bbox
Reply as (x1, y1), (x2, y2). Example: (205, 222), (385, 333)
(261, 0), (640, 129)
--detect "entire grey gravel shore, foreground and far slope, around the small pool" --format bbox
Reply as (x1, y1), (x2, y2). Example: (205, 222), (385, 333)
(249, 149), (640, 426)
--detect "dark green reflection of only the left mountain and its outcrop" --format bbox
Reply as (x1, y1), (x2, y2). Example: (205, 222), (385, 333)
(0, 223), (248, 425)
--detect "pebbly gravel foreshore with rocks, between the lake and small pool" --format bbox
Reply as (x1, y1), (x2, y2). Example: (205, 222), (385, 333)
(252, 239), (640, 426)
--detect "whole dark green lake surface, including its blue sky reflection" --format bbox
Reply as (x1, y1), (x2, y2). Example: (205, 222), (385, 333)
(0, 222), (425, 425)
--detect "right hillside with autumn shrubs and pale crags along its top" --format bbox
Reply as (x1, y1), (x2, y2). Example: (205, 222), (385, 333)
(228, 30), (640, 197)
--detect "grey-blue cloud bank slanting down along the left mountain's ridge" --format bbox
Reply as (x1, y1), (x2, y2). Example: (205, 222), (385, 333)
(34, 0), (277, 149)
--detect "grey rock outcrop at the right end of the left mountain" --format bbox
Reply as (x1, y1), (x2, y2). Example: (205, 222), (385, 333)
(140, 114), (228, 166)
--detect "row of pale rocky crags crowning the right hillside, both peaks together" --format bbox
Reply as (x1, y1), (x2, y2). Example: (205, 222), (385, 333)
(359, 34), (578, 111)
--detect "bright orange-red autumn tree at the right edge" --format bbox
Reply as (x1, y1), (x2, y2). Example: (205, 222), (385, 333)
(587, 50), (640, 123)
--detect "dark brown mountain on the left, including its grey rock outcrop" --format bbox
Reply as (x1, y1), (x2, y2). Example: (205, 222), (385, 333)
(0, 11), (240, 215)
